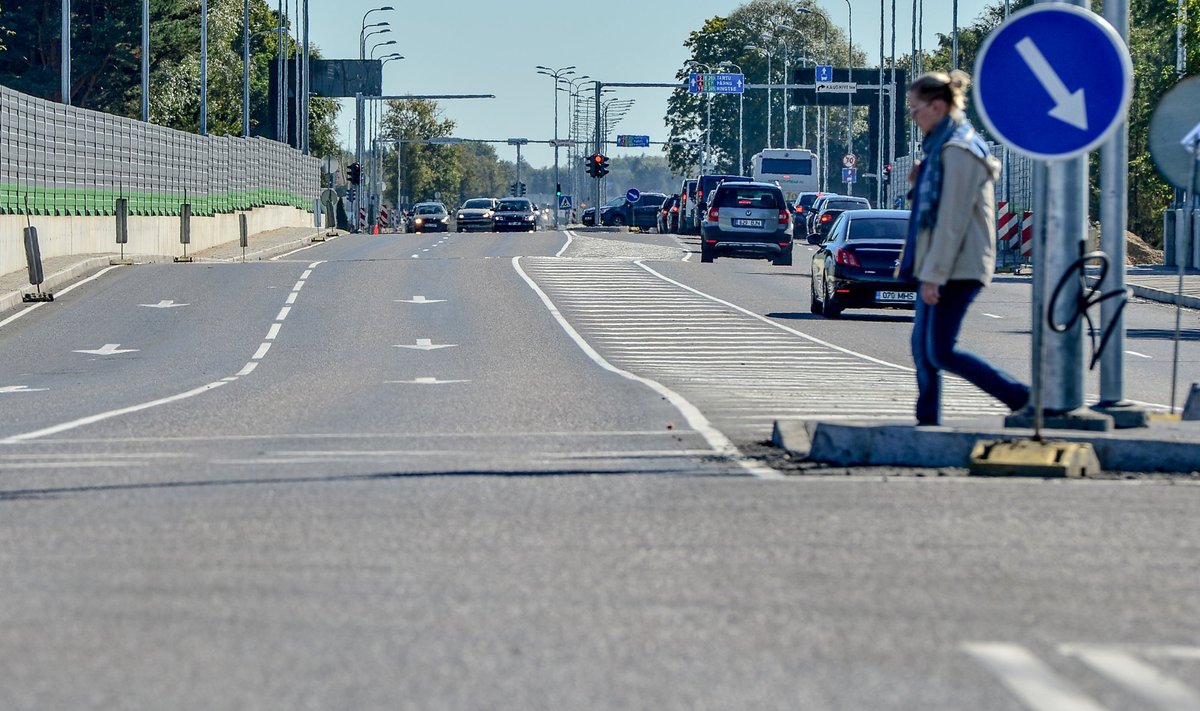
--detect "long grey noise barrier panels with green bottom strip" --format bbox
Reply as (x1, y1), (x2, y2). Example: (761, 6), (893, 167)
(0, 86), (320, 216)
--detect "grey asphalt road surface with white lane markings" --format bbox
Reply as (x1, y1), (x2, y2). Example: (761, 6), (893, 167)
(0, 232), (1200, 711)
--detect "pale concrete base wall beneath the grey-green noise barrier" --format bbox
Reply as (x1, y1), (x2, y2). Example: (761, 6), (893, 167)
(0, 205), (313, 274)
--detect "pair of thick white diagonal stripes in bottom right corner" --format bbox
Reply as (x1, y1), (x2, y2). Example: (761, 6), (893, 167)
(962, 643), (1200, 711)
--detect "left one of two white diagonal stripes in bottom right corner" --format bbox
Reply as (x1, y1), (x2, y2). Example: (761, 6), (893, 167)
(962, 643), (1104, 711)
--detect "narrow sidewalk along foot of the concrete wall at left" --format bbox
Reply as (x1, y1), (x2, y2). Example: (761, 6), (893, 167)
(0, 227), (343, 313)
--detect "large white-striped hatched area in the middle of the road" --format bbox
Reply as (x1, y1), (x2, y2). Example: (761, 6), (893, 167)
(522, 257), (1008, 441)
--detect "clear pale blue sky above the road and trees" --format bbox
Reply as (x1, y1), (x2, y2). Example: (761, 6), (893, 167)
(309, 0), (992, 166)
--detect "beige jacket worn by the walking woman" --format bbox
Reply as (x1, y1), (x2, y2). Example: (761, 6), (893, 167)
(913, 142), (1000, 285)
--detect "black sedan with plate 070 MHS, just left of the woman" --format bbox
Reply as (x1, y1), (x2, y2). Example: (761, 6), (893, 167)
(809, 210), (917, 318)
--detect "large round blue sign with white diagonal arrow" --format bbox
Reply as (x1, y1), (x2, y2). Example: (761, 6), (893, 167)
(974, 4), (1133, 160)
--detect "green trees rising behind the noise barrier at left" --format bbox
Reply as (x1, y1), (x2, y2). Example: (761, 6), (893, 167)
(0, 0), (338, 156)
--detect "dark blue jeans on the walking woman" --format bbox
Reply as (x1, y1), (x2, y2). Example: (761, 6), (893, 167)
(912, 276), (1030, 425)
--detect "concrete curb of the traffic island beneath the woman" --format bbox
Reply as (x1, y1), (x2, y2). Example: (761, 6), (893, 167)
(772, 420), (1200, 473)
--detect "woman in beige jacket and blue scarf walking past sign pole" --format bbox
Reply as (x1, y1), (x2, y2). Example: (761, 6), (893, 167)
(898, 70), (1030, 425)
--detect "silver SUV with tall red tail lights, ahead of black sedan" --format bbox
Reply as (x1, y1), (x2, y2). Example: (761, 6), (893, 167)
(697, 183), (792, 267)
